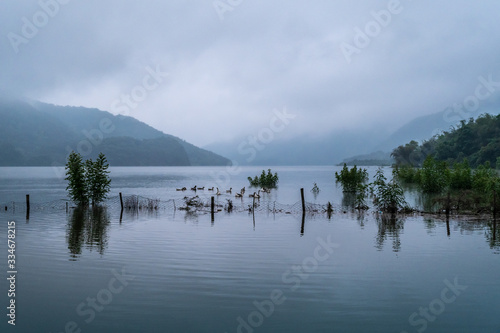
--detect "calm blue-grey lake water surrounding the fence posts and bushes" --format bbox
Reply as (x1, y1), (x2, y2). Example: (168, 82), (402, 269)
(0, 166), (500, 333)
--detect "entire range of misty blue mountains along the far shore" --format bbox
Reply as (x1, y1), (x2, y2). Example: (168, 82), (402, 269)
(0, 94), (500, 166)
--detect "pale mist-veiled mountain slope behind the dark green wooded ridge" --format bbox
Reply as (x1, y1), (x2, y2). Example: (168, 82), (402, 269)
(205, 97), (500, 165)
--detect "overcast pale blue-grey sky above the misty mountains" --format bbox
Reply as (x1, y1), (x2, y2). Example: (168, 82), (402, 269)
(0, 0), (500, 146)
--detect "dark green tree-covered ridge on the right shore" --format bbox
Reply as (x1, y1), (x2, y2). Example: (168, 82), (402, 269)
(391, 114), (500, 168)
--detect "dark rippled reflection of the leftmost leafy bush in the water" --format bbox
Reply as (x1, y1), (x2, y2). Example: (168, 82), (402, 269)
(67, 207), (110, 260)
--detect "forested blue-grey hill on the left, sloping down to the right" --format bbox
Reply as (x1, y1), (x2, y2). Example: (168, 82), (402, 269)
(0, 96), (230, 166)
